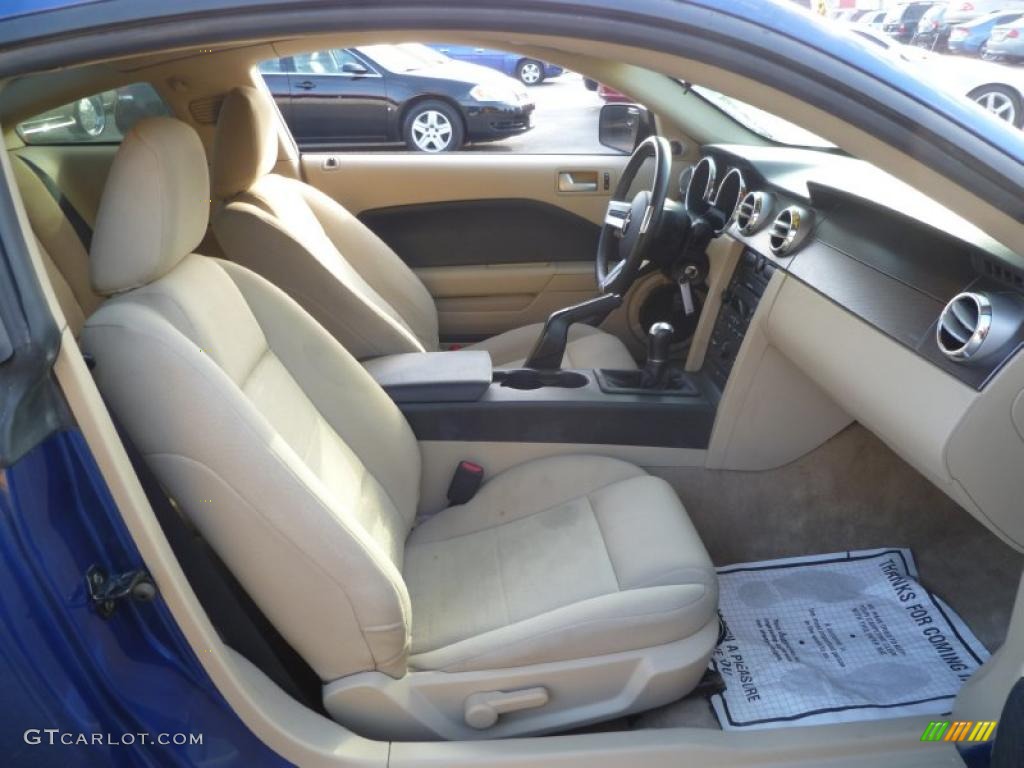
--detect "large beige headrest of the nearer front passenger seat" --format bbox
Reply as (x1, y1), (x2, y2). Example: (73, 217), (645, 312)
(89, 118), (210, 296)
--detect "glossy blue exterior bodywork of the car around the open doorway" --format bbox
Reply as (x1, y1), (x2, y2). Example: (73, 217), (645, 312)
(0, 0), (1024, 768)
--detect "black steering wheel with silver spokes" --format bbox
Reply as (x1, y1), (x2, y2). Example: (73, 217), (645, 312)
(595, 136), (672, 295)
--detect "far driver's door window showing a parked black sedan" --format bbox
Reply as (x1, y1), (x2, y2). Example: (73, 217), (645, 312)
(259, 41), (633, 155)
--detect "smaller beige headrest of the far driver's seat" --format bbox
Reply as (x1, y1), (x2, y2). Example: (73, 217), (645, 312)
(213, 85), (278, 200)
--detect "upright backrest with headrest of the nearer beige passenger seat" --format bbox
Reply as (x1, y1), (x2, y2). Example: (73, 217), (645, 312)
(83, 118), (420, 680)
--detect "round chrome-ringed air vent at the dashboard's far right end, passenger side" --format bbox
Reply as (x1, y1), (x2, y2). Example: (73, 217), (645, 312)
(935, 293), (1024, 362)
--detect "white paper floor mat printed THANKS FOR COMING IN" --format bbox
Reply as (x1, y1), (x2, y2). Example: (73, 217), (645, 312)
(712, 549), (988, 730)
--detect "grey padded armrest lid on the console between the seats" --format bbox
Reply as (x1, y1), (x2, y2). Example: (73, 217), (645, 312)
(365, 350), (494, 403)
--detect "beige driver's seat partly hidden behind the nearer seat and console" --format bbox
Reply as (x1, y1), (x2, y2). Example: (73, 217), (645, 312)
(213, 87), (636, 369)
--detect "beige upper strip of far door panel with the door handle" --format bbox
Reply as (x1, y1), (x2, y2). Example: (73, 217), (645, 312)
(302, 152), (629, 224)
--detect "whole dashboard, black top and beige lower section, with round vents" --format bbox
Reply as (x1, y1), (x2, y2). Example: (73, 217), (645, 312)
(680, 145), (1024, 549)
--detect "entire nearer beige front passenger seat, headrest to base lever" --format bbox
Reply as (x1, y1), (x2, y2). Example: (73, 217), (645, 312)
(83, 118), (718, 738)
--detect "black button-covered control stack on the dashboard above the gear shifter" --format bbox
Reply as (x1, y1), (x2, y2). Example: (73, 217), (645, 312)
(701, 249), (775, 392)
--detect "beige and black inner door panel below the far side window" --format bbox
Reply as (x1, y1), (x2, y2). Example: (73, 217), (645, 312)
(302, 152), (629, 340)
